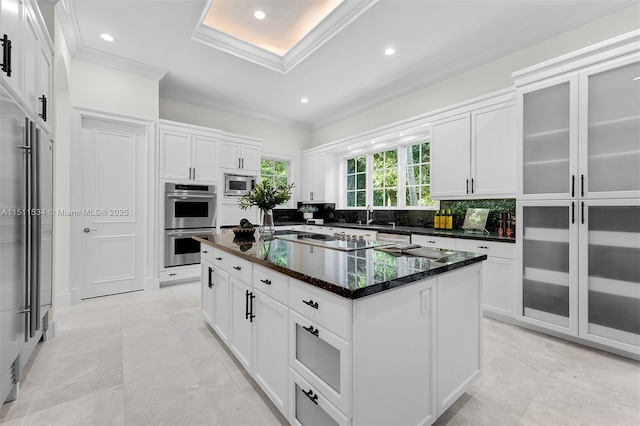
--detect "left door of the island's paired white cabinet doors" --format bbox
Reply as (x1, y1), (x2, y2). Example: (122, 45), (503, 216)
(229, 277), (255, 374)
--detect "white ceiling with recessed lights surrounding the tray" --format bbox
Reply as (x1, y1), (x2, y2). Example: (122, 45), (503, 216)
(60, 0), (635, 129)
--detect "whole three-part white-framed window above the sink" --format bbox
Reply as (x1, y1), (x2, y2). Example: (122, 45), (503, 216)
(344, 138), (437, 207)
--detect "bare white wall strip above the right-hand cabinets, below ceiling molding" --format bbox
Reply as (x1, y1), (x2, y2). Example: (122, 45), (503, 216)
(311, 3), (640, 147)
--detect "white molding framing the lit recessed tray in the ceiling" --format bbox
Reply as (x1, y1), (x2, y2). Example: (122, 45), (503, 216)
(191, 0), (378, 74)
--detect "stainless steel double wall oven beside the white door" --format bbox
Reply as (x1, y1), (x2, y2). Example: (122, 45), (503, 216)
(164, 183), (216, 268)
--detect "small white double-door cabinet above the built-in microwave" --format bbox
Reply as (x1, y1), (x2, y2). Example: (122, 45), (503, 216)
(218, 133), (262, 174)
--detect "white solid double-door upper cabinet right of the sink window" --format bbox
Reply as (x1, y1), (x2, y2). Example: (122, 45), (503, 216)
(431, 95), (516, 198)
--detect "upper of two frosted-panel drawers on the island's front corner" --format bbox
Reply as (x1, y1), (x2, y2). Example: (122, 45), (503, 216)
(289, 312), (351, 414)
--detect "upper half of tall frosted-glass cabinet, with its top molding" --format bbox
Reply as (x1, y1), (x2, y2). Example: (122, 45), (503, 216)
(514, 31), (640, 199)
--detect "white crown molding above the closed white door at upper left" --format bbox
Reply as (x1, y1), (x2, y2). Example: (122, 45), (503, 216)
(56, 0), (167, 80)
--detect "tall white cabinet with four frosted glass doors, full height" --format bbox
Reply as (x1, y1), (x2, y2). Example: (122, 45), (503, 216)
(514, 31), (640, 356)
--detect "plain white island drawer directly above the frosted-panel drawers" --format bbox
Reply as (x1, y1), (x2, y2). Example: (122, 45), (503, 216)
(289, 279), (351, 341)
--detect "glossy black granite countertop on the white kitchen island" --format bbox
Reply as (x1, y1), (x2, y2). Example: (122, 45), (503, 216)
(194, 232), (487, 299)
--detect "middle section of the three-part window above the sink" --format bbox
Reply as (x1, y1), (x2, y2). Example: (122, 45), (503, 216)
(372, 149), (398, 206)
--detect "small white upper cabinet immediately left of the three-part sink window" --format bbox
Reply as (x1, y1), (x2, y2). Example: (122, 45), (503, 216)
(300, 153), (338, 203)
